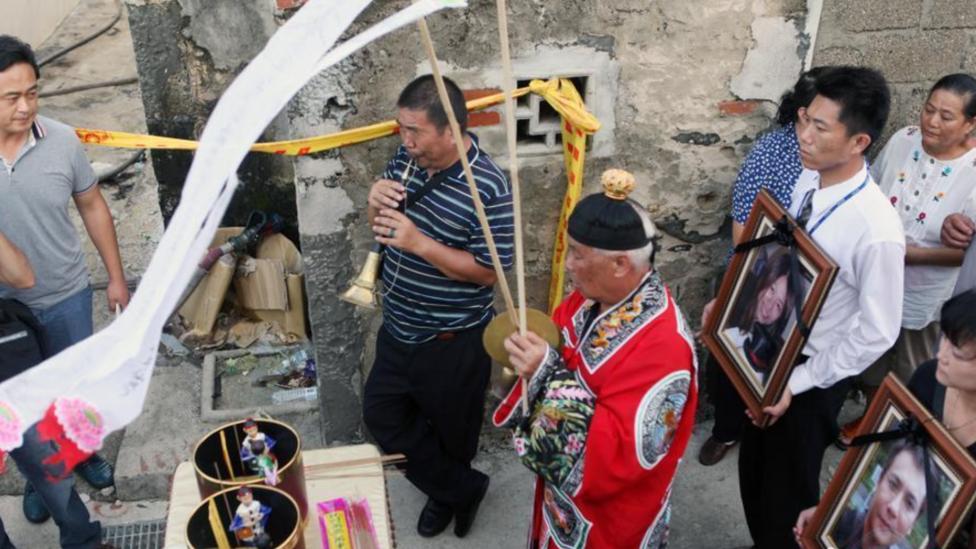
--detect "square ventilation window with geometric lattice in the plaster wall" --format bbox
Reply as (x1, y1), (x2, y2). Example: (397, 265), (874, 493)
(515, 76), (591, 154)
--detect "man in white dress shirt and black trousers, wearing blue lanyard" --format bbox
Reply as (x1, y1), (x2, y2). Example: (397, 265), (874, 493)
(739, 67), (905, 549)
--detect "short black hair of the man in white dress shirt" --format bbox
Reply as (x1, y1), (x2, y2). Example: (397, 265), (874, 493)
(814, 66), (891, 152)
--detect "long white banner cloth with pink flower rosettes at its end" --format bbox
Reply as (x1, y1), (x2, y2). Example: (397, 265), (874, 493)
(0, 0), (466, 467)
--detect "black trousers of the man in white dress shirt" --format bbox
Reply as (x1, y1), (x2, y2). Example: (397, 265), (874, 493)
(739, 372), (850, 549)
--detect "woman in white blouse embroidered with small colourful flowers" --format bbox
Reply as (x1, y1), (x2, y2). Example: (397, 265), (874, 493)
(863, 74), (976, 391)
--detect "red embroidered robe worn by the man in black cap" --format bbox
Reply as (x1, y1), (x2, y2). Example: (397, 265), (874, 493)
(493, 272), (698, 549)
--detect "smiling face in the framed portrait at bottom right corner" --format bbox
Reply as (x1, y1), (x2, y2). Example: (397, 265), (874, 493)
(864, 451), (925, 547)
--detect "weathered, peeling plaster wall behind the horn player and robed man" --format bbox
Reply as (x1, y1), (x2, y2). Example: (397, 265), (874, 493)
(127, 0), (809, 442)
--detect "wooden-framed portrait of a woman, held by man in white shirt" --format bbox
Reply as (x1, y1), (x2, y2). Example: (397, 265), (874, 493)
(702, 190), (837, 424)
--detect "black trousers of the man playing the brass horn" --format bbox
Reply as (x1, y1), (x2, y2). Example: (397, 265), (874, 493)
(363, 327), (491, 509)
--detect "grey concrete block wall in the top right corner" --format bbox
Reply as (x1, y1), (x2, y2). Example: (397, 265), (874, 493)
(814, 0), (976, 148)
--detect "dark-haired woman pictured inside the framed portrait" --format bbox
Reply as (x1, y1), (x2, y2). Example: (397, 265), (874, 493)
(722, 245), (802, 386)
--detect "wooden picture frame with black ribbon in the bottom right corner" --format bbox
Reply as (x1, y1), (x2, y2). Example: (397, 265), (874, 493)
(802, 374), (976, 549)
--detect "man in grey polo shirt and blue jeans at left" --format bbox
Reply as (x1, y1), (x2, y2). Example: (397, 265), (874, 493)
(0, 35), (129, 536)
